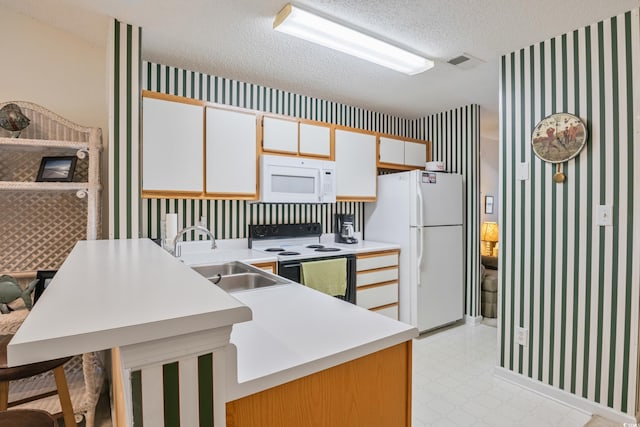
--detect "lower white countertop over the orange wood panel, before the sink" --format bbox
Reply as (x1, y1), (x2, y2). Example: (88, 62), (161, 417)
(227, 283), (418, 400)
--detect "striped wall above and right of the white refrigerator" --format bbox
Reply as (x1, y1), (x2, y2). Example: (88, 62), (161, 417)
(419, 105), (480, 317)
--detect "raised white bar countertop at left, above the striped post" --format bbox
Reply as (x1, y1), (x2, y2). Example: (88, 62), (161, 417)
(8, 239), (251, 365)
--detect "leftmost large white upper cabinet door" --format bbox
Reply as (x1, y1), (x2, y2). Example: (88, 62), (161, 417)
(142, 98), (204, 193)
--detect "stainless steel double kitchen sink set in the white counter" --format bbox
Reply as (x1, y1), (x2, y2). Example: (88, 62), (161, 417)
(191, 261), (288, 292)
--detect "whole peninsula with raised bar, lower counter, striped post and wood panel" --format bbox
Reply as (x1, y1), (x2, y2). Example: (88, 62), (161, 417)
(8, 239), (417, 426)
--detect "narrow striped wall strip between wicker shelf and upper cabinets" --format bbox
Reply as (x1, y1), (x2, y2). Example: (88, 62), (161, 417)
(108, 19), (142, 239)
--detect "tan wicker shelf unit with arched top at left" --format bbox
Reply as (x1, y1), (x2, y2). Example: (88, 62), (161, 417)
(0, 101), (105, 427)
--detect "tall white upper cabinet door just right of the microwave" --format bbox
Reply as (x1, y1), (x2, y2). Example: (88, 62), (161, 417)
(335, 129), (378, 201)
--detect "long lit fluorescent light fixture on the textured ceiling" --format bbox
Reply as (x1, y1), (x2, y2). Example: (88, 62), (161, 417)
(273, 3), (434, 75)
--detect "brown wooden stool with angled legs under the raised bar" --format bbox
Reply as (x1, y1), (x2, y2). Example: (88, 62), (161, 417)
(0, 335), (76, 427)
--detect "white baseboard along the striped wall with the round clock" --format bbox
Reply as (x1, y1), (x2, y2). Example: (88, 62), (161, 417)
(493, 366), (638, 424)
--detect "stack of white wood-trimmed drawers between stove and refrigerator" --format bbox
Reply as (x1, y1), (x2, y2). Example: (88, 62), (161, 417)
(356, 250), (400, 320)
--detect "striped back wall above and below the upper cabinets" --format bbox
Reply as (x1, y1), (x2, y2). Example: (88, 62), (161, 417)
(140, 62), (418, 239)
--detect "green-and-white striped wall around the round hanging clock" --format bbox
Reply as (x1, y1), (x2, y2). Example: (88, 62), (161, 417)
(498, 9), (640, 415)
